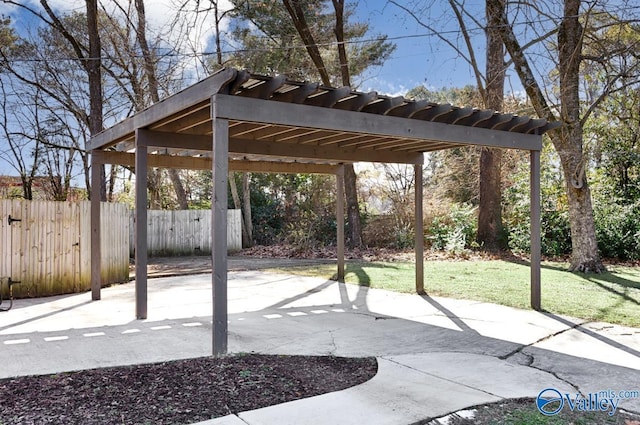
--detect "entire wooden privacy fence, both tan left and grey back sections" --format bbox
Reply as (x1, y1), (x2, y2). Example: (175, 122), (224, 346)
(0, 199), (242, 298)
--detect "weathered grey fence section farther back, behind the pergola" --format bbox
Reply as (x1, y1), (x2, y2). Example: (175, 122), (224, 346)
(129, 210), (242, 257)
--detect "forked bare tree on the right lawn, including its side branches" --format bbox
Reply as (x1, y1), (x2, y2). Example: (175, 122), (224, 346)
(498, 0), (640, 272)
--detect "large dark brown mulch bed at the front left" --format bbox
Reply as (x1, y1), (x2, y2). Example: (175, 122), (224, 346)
(0, 354), (377, 425)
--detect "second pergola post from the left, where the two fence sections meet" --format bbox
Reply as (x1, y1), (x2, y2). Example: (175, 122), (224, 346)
(135, 130), (149, 320)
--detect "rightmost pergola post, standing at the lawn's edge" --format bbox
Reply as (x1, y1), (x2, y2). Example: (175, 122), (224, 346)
(530, 150), (542, 311)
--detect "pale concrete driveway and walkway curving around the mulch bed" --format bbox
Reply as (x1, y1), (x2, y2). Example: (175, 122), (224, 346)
(0, 270), (640, 425)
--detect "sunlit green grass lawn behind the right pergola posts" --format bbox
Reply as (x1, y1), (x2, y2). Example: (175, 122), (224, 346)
(264, 260), (640, 327)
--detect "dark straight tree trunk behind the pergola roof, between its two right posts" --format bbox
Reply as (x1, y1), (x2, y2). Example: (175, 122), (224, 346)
(476, 0), (507, 251)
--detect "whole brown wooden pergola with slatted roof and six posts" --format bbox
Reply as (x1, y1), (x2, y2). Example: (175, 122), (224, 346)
(89, 69), (555, 355)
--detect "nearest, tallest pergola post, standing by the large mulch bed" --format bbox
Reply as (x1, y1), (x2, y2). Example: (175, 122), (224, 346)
(211, 96), (229, 356)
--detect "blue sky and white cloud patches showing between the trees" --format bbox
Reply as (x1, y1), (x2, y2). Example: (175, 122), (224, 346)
(0, 0), (484, 95)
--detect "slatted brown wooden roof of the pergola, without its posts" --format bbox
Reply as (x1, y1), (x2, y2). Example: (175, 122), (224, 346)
(89, 69), (559, 161)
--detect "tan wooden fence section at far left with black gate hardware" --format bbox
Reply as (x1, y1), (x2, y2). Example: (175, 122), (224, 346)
(0, 200), (129, 297)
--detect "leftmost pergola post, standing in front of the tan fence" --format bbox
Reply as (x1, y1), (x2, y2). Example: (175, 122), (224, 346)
(90, 149), (103, 301)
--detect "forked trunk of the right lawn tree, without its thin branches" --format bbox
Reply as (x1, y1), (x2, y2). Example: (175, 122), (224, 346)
(498, 0), (605, 272)
